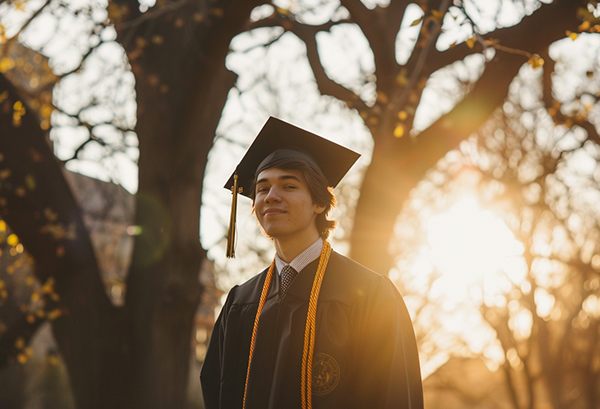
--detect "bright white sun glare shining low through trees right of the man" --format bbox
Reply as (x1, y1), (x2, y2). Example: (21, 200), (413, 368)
(412, 191), (531, 373)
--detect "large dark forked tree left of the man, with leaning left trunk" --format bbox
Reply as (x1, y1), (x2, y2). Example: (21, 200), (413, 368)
(0, 1), (264, 408)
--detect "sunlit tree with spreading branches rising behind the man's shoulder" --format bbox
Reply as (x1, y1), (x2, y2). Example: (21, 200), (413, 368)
(223, 0), (587, 272)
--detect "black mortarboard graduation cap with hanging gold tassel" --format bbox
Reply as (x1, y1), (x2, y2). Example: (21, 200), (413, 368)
(225, 117), (360, 257)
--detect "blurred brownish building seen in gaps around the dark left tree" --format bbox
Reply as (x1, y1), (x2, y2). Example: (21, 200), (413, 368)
(0, 171), (222, 409)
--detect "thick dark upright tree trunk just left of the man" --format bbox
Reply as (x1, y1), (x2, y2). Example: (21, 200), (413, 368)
(117, 0), (268, 409)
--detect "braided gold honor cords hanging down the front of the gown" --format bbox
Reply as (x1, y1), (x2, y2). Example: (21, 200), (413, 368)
(242, 242), (331, 409)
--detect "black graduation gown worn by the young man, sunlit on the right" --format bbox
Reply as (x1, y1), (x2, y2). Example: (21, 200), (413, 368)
(200, 252), (423, 409)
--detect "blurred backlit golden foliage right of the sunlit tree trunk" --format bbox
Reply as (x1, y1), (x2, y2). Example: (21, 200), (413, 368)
(395, 26), (600, 409)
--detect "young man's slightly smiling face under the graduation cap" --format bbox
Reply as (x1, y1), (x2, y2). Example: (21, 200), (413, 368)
(254, 168), (325, 239)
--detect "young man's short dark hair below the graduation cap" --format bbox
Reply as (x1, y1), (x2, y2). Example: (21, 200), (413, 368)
(250, 158), (337, 240)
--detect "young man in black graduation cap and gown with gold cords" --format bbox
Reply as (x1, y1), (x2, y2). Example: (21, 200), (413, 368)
(200, 118), (423, 409)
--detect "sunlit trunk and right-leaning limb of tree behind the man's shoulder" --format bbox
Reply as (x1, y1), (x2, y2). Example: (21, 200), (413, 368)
(350, 0), (579, 274)
